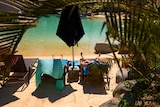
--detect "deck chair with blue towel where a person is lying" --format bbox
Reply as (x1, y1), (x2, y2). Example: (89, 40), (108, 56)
(81, 62), (110, 89)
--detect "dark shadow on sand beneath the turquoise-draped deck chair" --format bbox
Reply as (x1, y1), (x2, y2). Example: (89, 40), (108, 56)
(32, 75), (76, 103)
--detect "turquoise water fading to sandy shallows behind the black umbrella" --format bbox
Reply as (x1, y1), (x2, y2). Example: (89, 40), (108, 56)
(18, 15), (109, 57)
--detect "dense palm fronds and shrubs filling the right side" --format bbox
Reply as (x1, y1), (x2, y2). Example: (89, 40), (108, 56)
(101, 0), (160, 106)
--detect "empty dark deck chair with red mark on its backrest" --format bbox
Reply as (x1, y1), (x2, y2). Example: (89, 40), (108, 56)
(9, 55), (31, 85)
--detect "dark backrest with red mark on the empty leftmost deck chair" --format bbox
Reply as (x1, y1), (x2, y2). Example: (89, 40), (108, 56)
(11, 55), (27, 72)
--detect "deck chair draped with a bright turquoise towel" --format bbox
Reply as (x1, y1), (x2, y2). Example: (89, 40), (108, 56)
(36, 59), (67, 90)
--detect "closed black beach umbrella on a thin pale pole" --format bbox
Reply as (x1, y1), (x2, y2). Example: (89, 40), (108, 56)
(56, 5), (84, 66)
